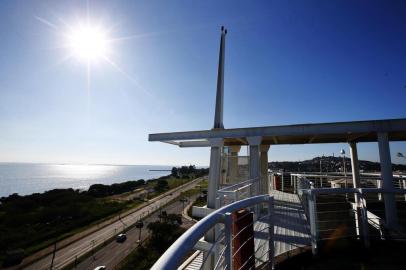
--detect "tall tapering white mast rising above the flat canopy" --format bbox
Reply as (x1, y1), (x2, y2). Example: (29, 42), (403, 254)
(214, 26), (227, 128)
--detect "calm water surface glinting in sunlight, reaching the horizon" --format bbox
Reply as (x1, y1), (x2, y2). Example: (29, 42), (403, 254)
(0, 163), (171, 197)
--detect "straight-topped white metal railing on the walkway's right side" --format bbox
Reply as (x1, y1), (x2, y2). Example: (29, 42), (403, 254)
(299, 187), (406, 254)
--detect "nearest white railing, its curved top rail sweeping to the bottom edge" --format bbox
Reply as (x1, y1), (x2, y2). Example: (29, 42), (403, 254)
(152, 195), (274, 270)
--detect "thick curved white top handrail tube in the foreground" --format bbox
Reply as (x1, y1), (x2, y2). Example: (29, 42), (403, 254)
(151, 195), (273, 270)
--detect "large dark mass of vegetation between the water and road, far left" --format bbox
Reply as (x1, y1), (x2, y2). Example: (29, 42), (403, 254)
(0, 189), (126, 265)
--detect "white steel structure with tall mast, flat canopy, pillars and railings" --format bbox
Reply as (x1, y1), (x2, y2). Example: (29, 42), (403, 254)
(148, 27), (406, 269)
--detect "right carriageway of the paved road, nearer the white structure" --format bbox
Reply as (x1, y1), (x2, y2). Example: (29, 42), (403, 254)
(73, 196), (197, 270)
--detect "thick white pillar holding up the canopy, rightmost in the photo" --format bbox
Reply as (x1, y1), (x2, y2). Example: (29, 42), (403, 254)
(378, 132), (398, 228)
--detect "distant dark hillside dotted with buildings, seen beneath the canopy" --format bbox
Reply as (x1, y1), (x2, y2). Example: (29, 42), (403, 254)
(268, 156), (406, 172)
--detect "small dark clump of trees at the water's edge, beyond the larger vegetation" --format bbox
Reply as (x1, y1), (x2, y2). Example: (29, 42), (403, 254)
(87, 179), (145, 197)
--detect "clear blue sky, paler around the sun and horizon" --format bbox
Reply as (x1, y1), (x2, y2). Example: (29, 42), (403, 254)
(0, 0), (406, 165)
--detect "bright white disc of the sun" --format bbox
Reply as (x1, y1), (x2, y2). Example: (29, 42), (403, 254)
(68, 25), (109, 61)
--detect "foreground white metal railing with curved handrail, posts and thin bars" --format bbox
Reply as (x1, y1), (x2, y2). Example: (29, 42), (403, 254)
(152, 195), (274, 270)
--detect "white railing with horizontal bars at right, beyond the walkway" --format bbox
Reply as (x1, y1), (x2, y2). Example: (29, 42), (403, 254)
(299, 184), (406, 254)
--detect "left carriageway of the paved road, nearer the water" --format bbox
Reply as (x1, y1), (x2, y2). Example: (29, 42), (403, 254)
(23, 177), (204, 270)
